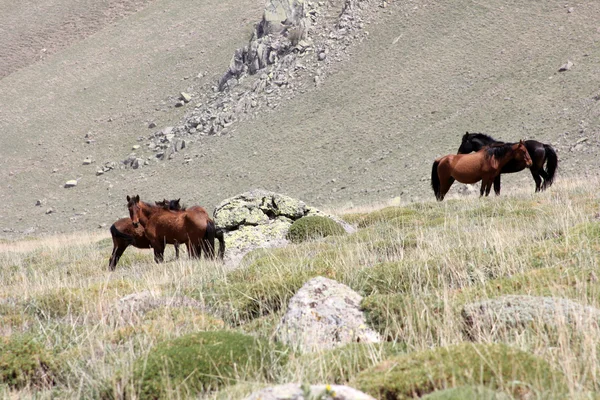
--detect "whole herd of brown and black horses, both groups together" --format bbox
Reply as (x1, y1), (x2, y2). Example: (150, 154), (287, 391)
(109, 132), (558, 271)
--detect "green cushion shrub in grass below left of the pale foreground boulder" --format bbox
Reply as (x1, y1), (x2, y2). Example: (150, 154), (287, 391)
(134, 331), (287, 399)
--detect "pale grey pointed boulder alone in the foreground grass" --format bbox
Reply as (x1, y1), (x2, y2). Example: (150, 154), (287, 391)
(275, 276), (381, 352)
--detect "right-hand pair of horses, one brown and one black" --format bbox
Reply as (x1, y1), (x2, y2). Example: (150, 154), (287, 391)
(431, 132), (558, 201)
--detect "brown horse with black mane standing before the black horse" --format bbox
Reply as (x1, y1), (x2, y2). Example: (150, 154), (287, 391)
(431, 140), (532, 201)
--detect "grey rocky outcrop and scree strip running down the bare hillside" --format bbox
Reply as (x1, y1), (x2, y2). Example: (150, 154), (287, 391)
(138, 0), (378, 160)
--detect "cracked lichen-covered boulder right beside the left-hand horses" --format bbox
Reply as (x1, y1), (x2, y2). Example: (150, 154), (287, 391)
(214, 189), (355, 265)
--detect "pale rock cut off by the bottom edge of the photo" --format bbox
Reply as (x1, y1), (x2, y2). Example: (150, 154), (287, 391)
(244, 383), (375, 400)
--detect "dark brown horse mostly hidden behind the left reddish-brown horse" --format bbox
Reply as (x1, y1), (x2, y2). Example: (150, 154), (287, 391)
(108, 199), (181, 271)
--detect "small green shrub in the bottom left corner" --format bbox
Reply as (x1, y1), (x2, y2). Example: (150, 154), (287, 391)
(0, 336), (57, 389)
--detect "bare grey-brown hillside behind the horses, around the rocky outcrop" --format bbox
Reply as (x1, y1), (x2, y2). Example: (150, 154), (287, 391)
(0, 0), (600, 235)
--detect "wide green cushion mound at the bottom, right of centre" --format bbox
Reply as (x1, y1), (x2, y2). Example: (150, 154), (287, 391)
(351, 343), (567, 399)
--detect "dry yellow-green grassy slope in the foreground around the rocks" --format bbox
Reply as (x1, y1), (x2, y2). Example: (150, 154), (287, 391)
(0, 181), (600, 399)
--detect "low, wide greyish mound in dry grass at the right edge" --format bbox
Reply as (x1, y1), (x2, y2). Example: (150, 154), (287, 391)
(461, 295), (600, 340)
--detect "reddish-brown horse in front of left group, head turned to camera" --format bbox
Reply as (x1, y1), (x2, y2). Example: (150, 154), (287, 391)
(127, 195), (225, 263)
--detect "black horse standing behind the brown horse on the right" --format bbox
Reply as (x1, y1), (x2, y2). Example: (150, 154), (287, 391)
(458, 132), (558, 195)
